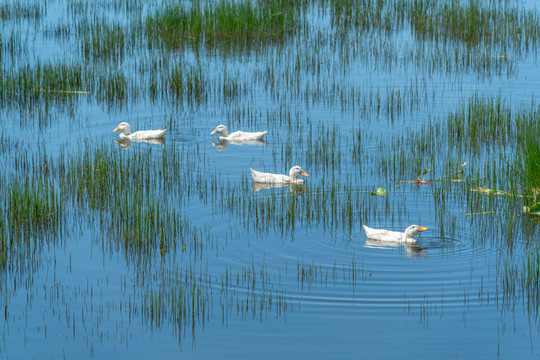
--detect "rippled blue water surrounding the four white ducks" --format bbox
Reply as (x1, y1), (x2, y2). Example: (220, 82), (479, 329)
(0, 0), (540, 359)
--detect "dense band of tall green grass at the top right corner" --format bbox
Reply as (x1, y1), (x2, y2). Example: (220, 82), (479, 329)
(321, 0), (540, 55)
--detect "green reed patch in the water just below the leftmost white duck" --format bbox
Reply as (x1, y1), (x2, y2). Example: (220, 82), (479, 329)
(55, 145), (219, 268)
